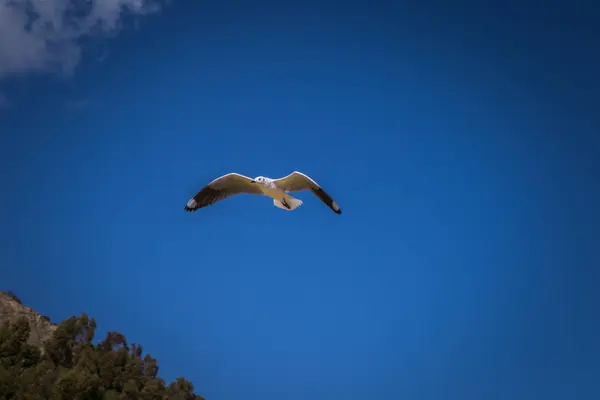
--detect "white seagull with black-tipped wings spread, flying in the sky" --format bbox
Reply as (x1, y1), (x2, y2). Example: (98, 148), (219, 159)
(184, 171), (342, 215)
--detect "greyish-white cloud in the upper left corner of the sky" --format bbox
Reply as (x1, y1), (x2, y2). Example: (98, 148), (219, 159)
(0, 0), (164, 79)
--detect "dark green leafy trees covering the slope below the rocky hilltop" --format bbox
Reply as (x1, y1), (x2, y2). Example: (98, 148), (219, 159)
(0, 313), (203, 400)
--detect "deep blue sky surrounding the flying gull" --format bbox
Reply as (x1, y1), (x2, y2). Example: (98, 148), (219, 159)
(0, 0), (600, 400)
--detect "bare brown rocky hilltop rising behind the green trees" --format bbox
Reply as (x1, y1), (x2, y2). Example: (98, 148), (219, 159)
(0, 291), (57, 346)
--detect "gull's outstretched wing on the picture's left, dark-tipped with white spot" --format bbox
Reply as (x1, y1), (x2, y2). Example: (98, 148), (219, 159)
(184, 172), (263, 212)
